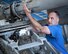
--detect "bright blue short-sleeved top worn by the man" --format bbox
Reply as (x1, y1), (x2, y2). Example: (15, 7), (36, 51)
(46, 25), (68, 54)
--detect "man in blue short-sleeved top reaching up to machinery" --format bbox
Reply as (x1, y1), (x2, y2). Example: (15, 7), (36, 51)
(23, 4), (68, 54)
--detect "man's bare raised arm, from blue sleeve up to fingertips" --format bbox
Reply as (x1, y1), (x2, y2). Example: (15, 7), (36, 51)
(24, 4), (50, 34)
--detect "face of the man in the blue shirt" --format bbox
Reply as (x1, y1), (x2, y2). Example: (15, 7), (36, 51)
(48, 12), (59, 25)
